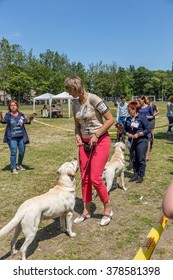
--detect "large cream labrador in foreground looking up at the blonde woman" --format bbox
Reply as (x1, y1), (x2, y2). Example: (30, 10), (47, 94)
(0, 159), (78, 260)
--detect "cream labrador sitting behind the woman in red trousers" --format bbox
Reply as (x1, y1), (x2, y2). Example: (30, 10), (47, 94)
(103, 142), (127, 192)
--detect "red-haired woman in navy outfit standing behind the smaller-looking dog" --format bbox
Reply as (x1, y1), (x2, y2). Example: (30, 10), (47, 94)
(124, 101), (150, 183)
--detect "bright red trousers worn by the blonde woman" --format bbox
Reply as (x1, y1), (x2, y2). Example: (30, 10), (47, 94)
(79, 134), (110, 203)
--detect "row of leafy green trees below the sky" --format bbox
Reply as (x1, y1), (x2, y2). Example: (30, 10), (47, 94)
(0, 38), (173, 101)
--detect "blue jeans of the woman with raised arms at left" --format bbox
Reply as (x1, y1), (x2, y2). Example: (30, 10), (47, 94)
(9, 138), (25, 169)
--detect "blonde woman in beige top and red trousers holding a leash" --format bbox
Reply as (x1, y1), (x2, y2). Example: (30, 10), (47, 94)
(65, 76), (114, 226)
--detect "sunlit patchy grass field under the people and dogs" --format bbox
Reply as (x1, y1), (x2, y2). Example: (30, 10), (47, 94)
(0, 102), (173, 260)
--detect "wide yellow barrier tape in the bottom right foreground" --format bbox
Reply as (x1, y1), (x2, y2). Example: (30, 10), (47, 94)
(134, 216), (168, 260)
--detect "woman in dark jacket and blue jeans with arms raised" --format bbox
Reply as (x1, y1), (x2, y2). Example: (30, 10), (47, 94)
(0, 100), (33, 175)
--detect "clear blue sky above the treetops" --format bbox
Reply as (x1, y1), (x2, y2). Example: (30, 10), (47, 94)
(0, 0), (173, 70)
